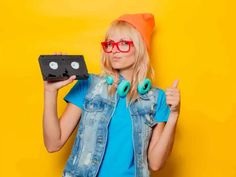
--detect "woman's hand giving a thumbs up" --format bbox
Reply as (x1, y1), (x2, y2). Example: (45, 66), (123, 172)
(165, 80), (180, 115)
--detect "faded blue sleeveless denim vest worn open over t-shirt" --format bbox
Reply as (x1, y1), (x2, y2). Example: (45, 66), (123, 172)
(63, 75), (158, 177)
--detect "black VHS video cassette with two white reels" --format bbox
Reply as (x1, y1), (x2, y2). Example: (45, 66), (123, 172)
(39, 55), (89, 81)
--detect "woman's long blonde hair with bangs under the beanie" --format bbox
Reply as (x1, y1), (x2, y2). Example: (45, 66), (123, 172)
(101, 21), (154, 103)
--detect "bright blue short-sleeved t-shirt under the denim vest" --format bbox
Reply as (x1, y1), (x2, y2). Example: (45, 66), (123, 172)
(64, 74), (170, 177)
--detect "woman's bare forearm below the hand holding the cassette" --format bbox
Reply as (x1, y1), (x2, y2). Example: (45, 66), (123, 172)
(43, 90), (61, 152)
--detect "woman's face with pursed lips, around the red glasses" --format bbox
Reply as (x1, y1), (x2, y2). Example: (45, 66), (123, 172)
(106, 30), (135, 71)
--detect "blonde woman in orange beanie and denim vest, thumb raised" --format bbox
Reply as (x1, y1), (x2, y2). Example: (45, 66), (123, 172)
(43, 13), (180, 177)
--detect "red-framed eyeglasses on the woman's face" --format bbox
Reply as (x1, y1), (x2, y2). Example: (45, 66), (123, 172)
(101, 40), (133, 53)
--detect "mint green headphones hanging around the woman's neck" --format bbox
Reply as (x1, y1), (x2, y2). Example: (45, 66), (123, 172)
(106, 76), (152, 97)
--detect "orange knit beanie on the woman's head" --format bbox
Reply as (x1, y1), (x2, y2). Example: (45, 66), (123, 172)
(116, 13), (155, 52)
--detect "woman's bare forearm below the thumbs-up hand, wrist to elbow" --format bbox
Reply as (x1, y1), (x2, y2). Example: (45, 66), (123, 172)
(148, 113), (178, 171)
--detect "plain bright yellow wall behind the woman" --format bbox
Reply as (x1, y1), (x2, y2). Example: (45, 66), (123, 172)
(0, 0), (236, 177)
